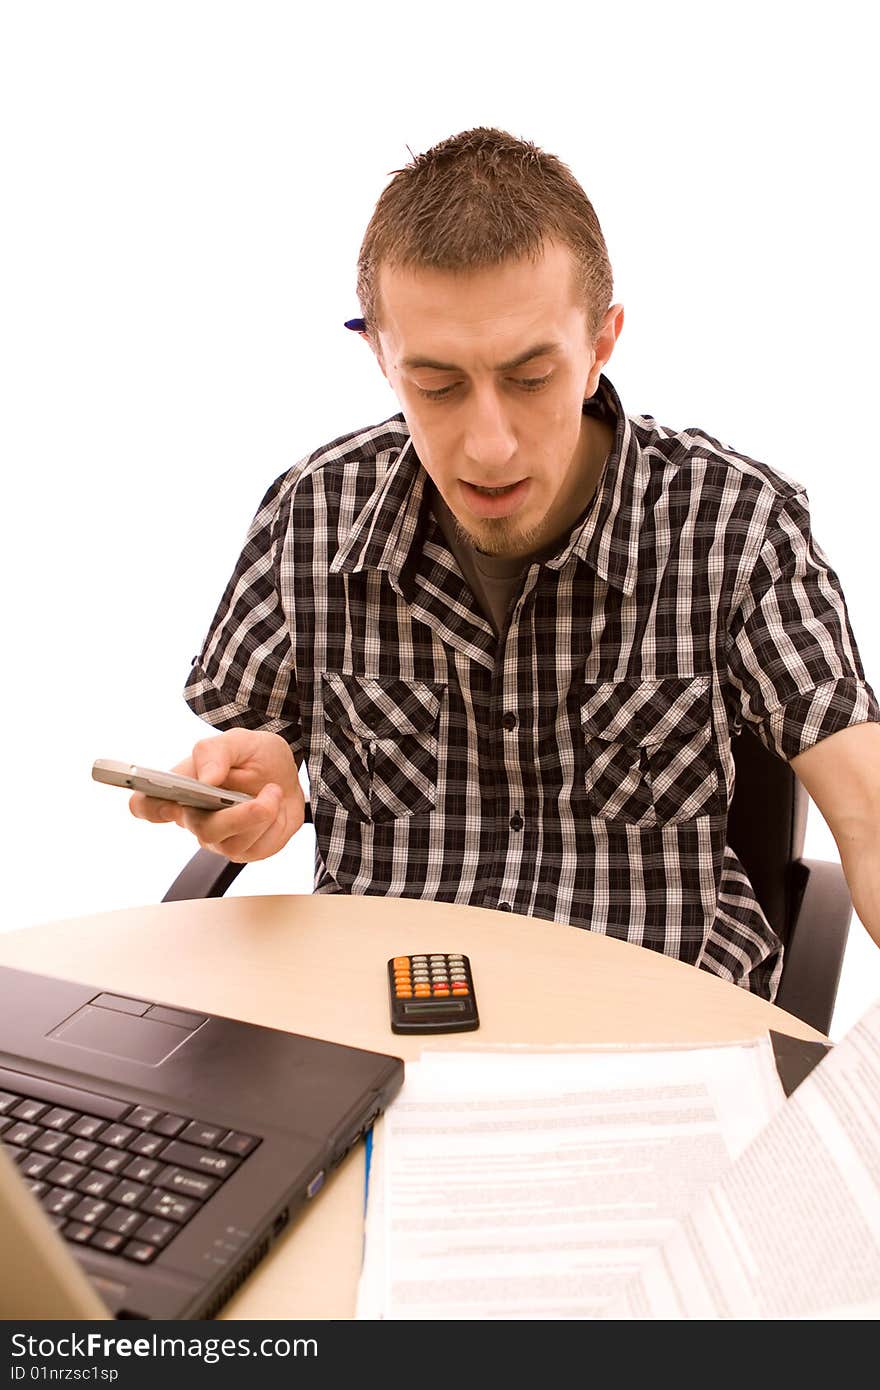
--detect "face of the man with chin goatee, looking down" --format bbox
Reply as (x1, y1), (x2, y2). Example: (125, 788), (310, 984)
(367, 243), (623, 556)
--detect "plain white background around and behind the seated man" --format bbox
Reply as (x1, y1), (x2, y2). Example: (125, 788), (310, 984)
(0, 0), (880, 1037)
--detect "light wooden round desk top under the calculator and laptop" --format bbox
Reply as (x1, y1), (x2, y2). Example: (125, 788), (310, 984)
(0, 895), (822, 1318)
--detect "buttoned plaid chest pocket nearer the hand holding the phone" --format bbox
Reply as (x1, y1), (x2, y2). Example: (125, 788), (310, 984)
(316, 671), (446, 820)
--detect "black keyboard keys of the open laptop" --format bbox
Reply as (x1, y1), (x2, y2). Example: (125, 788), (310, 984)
(0, 1068), (260, 1265)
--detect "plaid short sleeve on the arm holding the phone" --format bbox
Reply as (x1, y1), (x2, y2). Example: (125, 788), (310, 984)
(184, 474), (302, 758)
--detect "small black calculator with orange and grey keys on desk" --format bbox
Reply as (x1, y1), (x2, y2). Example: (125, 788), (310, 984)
(388, 952), (480, 1033)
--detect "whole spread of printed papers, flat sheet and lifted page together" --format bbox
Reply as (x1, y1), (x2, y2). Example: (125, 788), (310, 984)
(359, 1002), (880, 1319)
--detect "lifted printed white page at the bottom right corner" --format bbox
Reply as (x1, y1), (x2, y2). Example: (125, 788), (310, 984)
(606, 1002), (880, 1319)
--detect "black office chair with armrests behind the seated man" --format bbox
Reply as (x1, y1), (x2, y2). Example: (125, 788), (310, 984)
(163, 730), (852, 1034)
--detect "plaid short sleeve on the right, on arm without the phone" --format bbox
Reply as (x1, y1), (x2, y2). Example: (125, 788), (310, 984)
(727, 492), (880, 759)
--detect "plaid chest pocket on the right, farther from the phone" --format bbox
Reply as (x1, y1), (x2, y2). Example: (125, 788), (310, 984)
(580, 676), (723, 826)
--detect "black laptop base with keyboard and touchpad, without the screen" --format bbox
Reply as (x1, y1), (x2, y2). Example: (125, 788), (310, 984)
(0, 967), (403, 1319)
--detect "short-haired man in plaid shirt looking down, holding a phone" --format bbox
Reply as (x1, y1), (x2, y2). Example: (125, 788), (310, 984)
(131, 129), (880, 999)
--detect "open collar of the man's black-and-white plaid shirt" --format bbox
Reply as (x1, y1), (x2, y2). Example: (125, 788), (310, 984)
(329, 375), (648, 594)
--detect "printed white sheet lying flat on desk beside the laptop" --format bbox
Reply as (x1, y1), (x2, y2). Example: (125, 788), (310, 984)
(357, 1038), (784, 1321)
